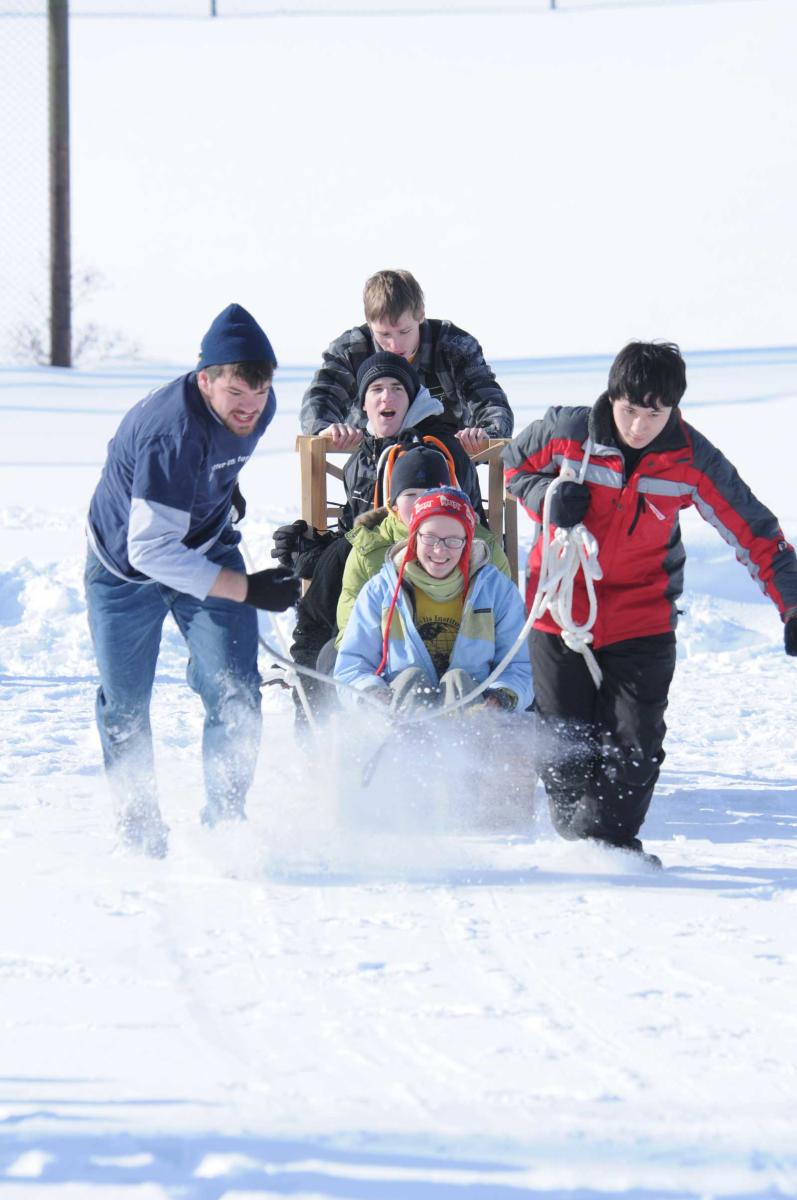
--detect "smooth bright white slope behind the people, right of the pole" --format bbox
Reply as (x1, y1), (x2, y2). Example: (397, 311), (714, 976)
(1, 0), (797, 364)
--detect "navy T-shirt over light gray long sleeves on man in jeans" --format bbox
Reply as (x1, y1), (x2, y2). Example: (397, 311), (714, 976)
(88, 372), (276, 600)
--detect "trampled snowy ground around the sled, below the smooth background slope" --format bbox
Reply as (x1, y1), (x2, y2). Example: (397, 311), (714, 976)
(0, 349), (797, 1200)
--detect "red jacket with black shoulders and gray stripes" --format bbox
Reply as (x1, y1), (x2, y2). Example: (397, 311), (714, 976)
(503, 394), (797, 648)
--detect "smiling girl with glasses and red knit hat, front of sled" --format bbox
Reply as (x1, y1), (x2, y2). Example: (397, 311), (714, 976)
(335, 487), (532, 712)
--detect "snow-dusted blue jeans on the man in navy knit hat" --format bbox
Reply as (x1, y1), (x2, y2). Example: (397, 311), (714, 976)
(85, 532), (260, 824)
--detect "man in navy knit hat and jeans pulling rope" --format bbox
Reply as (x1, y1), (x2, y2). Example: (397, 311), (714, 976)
(85, 304), (299, 858)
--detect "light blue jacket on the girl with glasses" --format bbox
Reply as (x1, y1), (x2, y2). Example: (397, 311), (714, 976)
(335, 546), (533, 710)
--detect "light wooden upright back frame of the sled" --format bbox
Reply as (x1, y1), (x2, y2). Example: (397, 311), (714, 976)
(296, 434), (517, 583)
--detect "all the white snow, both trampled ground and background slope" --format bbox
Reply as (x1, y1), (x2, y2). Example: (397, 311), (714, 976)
(0, 0), (797, 1200)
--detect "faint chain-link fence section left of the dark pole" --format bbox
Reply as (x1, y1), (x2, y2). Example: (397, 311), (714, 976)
(0, 0), (49, 362)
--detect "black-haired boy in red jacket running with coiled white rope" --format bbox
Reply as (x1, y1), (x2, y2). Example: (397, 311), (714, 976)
(504, 342), (797, 865)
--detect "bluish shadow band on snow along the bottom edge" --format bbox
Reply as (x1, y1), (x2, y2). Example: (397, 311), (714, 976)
(0, 1123), (780, 1200)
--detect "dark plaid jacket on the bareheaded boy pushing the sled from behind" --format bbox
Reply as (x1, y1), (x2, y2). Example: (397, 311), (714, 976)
(300, 318), (515, 438)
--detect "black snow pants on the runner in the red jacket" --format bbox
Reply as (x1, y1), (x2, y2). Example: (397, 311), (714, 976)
(531, 630), (676, 846)
